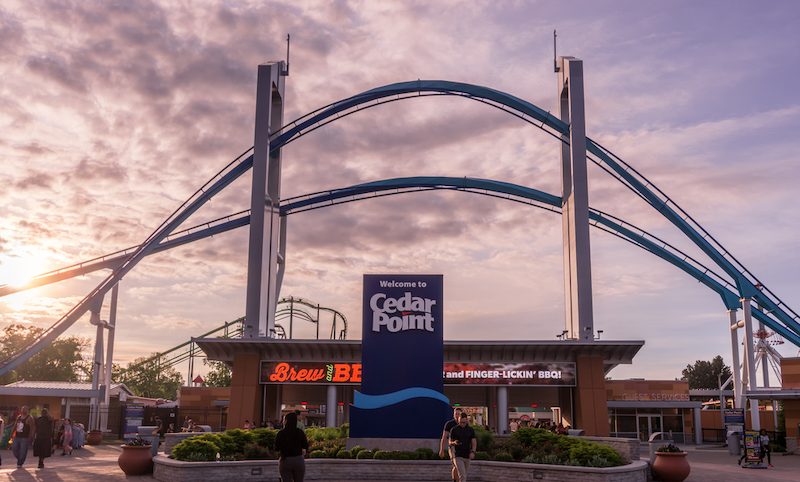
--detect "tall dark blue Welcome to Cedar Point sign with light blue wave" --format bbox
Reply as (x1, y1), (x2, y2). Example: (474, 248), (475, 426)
(350, 275), (452, 438)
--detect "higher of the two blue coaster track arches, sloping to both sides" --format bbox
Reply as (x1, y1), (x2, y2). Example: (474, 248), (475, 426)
(0, 80), (800, 375)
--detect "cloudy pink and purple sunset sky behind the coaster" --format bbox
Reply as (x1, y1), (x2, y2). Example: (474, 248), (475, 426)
(0, 0), (800, 384)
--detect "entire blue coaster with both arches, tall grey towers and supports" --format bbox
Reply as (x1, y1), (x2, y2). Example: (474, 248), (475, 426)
(0, 57), (800, 429)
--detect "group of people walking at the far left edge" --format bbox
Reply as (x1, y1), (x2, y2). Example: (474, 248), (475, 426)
(0, 406), (84, 469)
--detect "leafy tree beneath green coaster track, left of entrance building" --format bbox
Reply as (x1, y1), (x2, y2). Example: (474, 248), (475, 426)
(116, 353), (183, 400)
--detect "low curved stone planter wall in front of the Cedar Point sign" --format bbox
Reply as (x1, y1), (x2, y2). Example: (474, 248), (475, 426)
(153, 455), (647, 482)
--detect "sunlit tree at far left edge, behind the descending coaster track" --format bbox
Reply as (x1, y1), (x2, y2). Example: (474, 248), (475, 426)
(0, 325), (90, 385)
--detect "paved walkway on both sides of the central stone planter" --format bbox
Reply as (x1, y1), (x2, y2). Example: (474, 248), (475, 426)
(0, 443), (800, 482)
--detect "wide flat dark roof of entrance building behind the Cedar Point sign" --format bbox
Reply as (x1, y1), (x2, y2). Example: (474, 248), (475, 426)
(192, 338), (644, 373)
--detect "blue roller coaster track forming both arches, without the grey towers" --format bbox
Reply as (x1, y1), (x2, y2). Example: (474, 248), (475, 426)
(0, 80), (800, 375)
